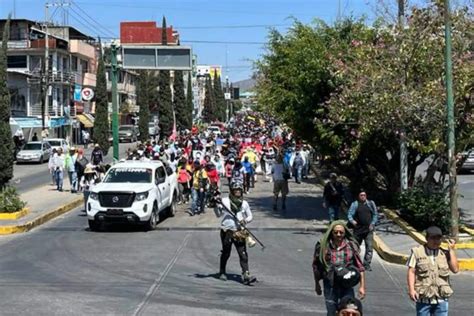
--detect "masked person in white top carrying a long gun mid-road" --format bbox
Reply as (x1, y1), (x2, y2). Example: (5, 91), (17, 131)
(219, 183), (256, 285)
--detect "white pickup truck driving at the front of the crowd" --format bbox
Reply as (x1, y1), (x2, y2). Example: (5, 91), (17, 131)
(86, 161), (178, 231)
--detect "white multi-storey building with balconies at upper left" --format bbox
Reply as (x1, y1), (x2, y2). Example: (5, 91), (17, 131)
(0, 19), (97, 140)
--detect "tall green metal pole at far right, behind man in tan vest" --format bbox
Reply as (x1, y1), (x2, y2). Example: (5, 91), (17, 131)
(444, 0), (459, 238)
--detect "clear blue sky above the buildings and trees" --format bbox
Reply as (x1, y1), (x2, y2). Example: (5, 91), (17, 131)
(0, 0), (452, 82)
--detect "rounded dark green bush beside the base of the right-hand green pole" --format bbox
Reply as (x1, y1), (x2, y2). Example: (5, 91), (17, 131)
(398, 187), (451, 233)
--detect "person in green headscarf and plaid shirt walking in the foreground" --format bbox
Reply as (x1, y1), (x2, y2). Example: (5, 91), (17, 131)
(313, 221), (365, 316)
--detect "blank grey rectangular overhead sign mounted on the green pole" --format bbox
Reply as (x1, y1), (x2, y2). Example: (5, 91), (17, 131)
(122, 45), (192, 70)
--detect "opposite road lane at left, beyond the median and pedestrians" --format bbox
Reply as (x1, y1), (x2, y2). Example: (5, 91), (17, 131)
(11, 143), (134, 193)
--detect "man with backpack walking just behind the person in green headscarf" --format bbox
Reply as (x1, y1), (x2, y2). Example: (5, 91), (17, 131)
(347, 189), (378, 271)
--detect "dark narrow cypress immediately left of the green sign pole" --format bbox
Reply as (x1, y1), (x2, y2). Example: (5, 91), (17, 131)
(94, 43), (110, 154)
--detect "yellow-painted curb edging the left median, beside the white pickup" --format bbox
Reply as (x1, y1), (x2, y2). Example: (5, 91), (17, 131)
(0, 196), (84, 235)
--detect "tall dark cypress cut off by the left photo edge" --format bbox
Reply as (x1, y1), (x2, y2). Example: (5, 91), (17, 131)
(0, 16), (14, 189)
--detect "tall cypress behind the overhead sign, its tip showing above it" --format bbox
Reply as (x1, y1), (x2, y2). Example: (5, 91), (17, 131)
(158, 17), (173, 136)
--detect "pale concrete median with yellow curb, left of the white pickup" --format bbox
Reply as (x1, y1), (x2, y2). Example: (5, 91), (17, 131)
(0, 184), (83, 235)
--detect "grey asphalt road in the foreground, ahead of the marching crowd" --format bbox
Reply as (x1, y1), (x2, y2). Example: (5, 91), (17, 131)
(0, 180), (474, 315)
